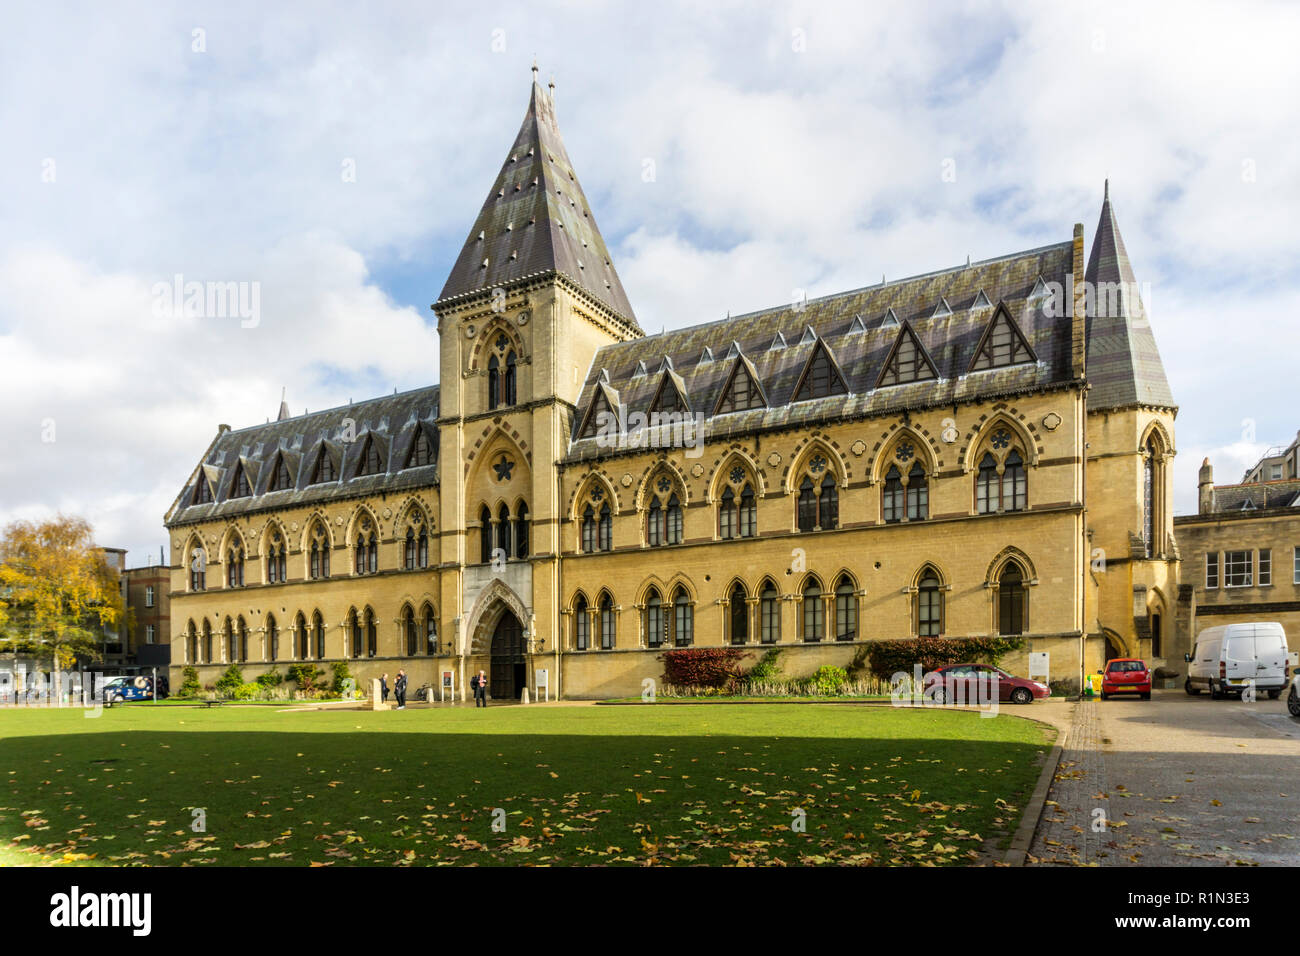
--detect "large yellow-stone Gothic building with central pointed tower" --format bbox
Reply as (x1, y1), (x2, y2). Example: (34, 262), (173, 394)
(165, 79), (1178, 698)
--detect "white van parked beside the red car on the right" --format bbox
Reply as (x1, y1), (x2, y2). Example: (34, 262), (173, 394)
(1183, 620), (1291, 700)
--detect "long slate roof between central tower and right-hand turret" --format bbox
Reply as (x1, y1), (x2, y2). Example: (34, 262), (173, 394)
(568, 241), (1074, 460)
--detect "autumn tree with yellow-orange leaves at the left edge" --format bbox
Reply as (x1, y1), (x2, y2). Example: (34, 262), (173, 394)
(0, 515), (127, 696)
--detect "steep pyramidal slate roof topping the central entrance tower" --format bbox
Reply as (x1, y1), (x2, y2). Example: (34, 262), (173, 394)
(438, 69), (640, 330)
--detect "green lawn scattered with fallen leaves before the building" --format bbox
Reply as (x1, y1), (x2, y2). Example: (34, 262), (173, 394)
(0, 704), (1052, 866)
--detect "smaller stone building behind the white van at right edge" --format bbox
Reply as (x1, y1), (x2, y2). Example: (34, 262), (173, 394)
(1169, 447), (1300, 666)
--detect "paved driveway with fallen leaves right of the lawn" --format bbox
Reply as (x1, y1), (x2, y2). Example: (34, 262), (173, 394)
(1026, 689), (1300, 866)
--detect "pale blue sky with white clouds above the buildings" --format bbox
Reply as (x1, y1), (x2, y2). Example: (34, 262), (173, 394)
(0, 0), (1300, 566)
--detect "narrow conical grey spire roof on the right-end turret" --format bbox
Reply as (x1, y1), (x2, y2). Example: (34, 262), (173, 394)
(1084, 182), (1175, 410)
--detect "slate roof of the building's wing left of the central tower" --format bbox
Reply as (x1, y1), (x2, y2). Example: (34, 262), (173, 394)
(164, 385), (439, 527)
